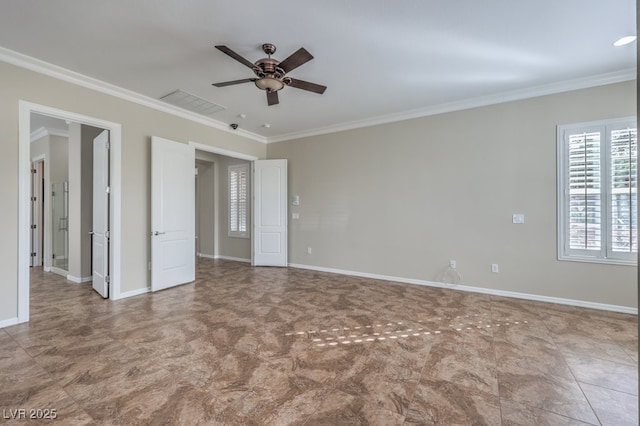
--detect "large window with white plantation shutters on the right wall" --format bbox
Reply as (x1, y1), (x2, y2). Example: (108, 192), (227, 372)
(558, 118), (638, 265)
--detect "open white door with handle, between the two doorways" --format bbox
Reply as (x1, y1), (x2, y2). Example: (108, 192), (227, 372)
(151, 136), (196, 291)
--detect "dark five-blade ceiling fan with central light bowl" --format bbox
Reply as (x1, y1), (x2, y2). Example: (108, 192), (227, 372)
(213, 43), (327, 106)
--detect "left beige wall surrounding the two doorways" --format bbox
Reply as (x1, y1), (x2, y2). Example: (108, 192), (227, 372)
(0, 62), (266, 321)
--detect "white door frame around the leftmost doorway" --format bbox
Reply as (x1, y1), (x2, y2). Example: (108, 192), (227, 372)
(18, 100), (122, 323)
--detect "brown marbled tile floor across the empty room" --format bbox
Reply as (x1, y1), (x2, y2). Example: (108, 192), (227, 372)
(0, 260), (638, 426)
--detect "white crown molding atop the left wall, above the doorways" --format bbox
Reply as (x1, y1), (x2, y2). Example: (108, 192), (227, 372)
(0, 46), (267, 143)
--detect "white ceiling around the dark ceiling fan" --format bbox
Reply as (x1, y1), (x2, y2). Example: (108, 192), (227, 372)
(0, 0), (636, 140)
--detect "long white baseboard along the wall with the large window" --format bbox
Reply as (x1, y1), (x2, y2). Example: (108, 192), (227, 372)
(289, 263), (638, 315)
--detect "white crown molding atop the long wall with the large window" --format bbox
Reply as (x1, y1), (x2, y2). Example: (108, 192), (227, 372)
(267, 68), (637, 143)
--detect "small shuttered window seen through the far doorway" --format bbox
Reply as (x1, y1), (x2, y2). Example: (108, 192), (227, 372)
(229, 164), (249, 238)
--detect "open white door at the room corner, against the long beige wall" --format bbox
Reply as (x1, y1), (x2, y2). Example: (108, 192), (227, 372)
(251, 160), (288, 266)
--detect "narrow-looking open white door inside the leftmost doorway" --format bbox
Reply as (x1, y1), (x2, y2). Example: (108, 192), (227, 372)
(91, 130), (109, 299)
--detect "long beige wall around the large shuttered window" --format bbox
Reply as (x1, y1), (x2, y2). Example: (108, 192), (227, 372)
(267, 82), (637, 307)
